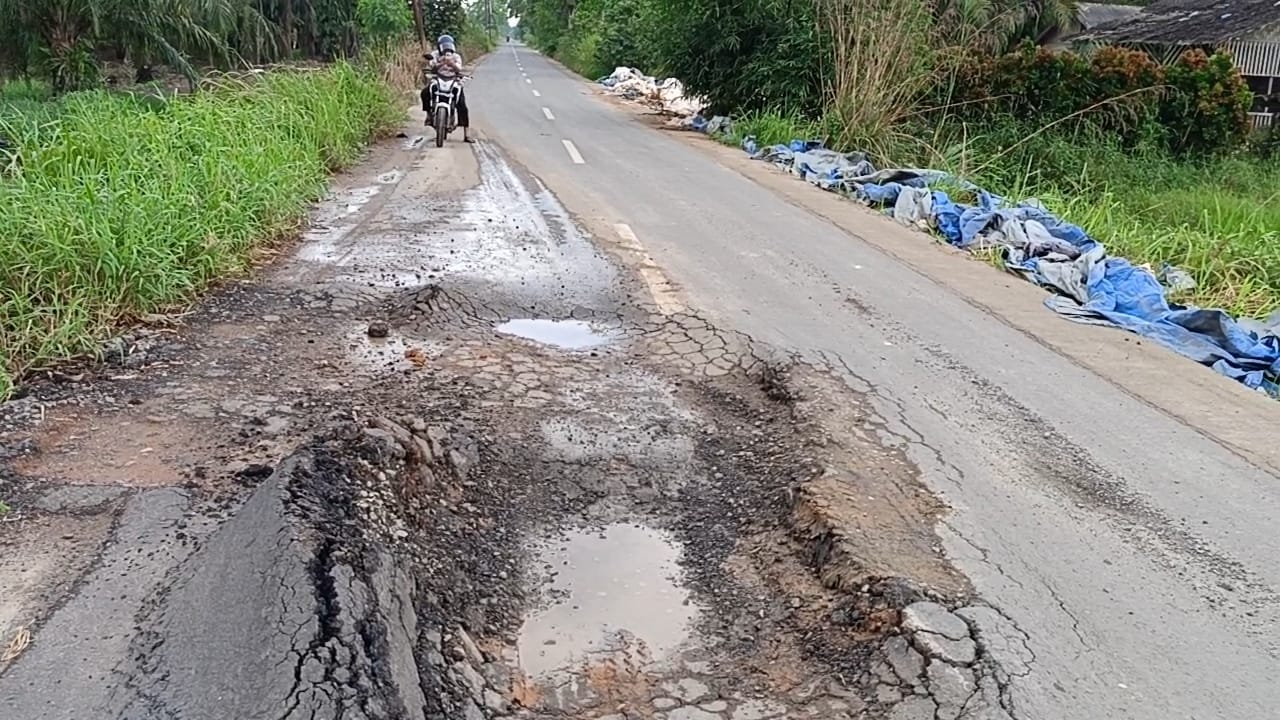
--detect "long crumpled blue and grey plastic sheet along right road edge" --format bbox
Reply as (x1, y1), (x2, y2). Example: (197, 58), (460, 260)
(742, 137), (1280, 396)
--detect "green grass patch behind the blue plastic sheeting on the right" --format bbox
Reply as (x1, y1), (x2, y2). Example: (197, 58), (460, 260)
(911, 119), (1280, 316)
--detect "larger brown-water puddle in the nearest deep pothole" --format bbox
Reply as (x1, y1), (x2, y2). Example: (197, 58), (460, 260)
(517, 523), (698, 679)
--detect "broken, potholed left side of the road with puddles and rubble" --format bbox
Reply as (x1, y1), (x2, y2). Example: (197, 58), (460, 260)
(0, 130), (1018, 720)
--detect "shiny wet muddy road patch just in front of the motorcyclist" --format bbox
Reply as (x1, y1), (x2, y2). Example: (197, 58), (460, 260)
(286, 138), (623, 311)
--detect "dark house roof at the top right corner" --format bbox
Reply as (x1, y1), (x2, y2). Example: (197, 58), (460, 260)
(1079, 0), (1280, 45)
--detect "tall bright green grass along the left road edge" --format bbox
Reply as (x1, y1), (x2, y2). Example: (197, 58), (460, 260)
(0, 64), (401, 397)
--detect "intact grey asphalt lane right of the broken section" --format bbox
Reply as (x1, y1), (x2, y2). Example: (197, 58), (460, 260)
(467, 45), (1280, 720)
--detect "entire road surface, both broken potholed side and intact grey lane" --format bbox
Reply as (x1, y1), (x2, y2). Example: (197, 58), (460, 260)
(0, 45), (1280, 720)
